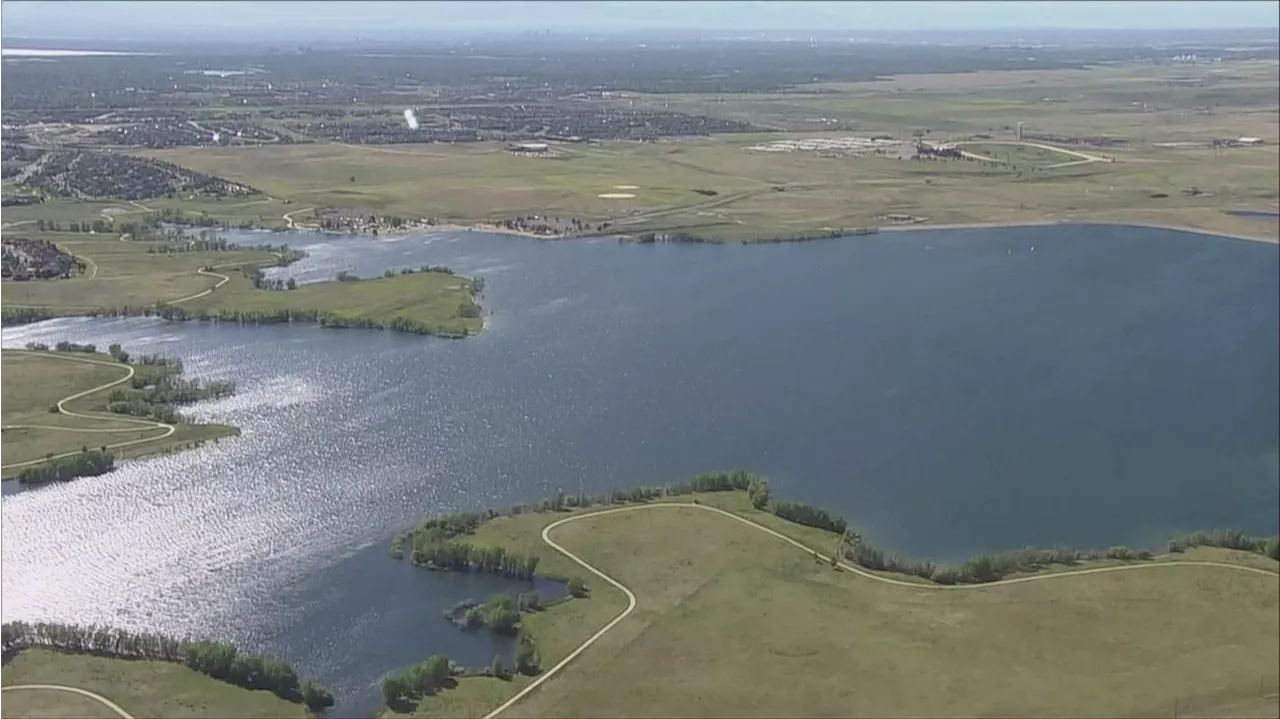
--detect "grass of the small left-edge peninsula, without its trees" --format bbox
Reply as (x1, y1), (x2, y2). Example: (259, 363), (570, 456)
(0, 352), (237, 478)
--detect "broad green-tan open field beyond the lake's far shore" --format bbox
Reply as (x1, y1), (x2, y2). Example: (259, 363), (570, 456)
(135, 137), (1280, 241)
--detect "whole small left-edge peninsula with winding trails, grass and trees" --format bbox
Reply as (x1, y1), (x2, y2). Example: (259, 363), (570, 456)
(0, 342), (239, 485)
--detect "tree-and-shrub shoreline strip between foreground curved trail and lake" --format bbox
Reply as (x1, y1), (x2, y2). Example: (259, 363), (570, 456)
(384, 471), (1280, 716)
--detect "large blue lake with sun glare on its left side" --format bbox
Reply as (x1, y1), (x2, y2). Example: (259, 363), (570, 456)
(0, 225), (1280, 715)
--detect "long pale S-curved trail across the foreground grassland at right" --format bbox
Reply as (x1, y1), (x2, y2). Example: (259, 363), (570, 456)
(484, 502), (1280, 719)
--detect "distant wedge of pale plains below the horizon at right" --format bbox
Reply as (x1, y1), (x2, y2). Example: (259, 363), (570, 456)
(618, 60), (1280, 136)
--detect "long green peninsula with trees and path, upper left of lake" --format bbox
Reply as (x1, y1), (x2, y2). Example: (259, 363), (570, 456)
(0, 212), (484, 339)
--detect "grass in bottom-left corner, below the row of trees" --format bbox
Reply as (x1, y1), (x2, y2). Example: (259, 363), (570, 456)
(0, 649), (307, 719)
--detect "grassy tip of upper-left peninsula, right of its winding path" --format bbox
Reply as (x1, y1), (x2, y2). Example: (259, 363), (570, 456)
(183, 270), (484, 334)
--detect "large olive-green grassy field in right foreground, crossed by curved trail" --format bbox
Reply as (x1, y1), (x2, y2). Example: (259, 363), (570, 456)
(388, 495), (1280, 716)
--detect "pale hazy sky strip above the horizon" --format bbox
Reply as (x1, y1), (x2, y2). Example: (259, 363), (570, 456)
(0, 0), (1280, 38)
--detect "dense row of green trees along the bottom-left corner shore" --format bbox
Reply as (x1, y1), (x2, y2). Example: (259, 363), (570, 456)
(0, 622), (333, 711)
